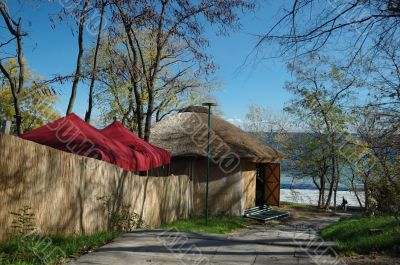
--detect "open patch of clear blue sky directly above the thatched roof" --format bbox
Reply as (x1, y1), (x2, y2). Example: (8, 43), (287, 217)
(207, 1), (291, 123)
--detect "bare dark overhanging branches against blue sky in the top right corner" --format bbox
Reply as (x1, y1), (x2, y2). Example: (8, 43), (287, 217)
(257, 0), (400, 63)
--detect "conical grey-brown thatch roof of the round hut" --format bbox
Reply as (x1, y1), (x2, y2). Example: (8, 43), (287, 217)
(150, 106), (284, 162)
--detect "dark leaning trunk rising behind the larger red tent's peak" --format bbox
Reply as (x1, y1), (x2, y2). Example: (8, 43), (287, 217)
(67, 0), (89, 114)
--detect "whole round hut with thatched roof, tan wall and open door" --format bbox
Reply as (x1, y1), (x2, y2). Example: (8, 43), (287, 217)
(151, 107), (283, 215)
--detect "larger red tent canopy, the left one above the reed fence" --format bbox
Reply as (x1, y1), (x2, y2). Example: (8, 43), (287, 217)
(21, 114), (138, 170)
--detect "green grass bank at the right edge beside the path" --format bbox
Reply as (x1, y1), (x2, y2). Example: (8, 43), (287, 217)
(321, 216), (400, 255)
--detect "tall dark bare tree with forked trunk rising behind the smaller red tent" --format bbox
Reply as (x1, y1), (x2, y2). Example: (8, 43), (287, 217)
(109, 0), (254, 140)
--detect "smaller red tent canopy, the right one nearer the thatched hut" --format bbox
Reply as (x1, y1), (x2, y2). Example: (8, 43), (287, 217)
(101, 121), (171, 169)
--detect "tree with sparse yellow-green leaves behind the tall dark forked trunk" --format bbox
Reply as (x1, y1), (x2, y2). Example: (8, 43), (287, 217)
(92, 29), (219, 132)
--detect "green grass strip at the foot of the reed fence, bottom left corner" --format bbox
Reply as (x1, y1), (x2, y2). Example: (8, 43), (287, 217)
(0, 232), (118, 265)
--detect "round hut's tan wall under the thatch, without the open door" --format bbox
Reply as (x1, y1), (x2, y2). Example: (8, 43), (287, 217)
(171, 157), (256, 216)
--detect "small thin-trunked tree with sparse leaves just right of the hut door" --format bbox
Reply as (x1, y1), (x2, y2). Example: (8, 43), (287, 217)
(286, 55), (356, 209)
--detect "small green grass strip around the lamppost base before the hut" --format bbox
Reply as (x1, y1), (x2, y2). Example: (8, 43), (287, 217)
(161, 216), (246, 234)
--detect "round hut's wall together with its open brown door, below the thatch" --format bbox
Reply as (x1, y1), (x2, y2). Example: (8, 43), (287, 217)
(171, 157), (280, 216)
